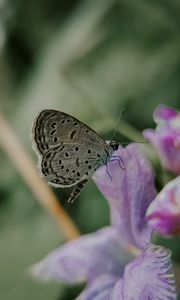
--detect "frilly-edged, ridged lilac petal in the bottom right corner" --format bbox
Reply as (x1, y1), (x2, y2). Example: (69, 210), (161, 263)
(112, 245), (177, 300)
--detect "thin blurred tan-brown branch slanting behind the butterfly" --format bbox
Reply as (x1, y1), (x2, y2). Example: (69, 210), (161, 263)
(0, 113), (80, 240)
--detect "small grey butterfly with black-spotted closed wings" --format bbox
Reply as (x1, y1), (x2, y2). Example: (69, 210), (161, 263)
(32, 110), (118, 201)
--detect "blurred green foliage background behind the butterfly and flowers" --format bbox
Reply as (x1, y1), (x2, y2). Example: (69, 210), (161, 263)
(0, 0), (180, 300)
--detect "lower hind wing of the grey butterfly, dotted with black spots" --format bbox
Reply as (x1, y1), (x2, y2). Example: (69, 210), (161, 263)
(41, 142), (107, 187)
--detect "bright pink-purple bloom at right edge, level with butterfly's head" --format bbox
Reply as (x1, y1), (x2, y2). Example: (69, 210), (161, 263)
(144, 105), (180, 174)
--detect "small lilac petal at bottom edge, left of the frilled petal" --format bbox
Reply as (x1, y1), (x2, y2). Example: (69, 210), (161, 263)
(76, 275), (117, 300)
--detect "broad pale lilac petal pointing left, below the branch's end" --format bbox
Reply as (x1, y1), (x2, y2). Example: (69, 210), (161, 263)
(31, 227), (132, 283)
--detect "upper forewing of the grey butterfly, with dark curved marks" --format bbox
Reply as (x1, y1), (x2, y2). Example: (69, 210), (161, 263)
(32, 109), (105, 155)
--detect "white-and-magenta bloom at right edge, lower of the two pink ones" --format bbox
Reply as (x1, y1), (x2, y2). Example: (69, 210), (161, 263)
(146, 176), (180, 235)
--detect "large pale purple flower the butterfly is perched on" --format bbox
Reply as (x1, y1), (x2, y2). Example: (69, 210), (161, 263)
(31, 145), (176, 300)
